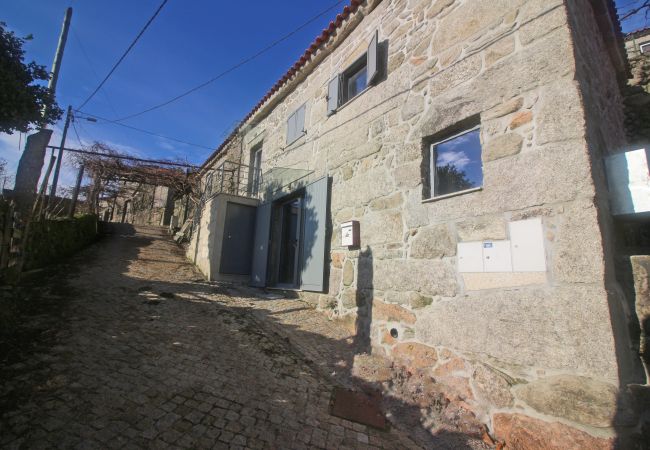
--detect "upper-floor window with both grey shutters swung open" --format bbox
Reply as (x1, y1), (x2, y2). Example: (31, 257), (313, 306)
(327, 31), (379, 116)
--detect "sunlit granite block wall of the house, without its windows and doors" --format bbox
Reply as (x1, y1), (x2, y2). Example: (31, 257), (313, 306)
(201, 0), (624, 448)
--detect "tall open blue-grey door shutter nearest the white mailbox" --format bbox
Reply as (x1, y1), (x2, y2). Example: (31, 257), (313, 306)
(300, 177), (327, 292)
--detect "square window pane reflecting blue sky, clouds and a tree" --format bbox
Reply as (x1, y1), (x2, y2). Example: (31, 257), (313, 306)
(431, 129), (483, 197)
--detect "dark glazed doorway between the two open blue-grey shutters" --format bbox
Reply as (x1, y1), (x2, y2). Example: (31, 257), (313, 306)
(271, 195), (303, 288)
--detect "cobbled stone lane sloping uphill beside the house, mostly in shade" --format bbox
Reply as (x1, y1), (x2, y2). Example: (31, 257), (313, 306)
(0, 227), (480, 449)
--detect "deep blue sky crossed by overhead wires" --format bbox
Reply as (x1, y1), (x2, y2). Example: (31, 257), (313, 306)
(0, 0), (648, 192)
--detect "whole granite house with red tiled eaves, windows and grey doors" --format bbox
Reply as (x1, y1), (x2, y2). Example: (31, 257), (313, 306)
(182, 0), (645, 448)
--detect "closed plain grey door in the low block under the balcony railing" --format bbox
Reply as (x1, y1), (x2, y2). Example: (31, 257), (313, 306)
(219, 202), (255, 275)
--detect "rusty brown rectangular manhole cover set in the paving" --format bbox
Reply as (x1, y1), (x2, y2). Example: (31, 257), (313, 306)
(331, 388), (388, 430)
